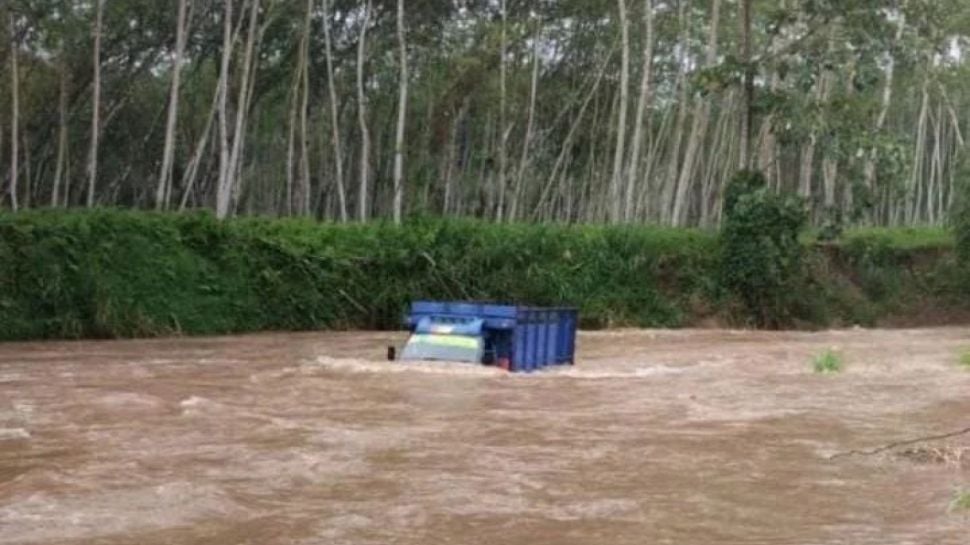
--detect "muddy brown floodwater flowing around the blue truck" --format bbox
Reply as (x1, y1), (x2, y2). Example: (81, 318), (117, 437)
(0, 328), (970, 545)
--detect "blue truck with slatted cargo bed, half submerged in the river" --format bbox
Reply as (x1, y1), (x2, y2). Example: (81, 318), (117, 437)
(400, 301), (578, 373)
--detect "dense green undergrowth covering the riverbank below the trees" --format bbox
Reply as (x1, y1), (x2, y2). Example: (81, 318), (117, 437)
(0, 210), (970, 340)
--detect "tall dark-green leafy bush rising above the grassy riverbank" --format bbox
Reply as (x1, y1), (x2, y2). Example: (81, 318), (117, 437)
(720, 171), (808, 327)
